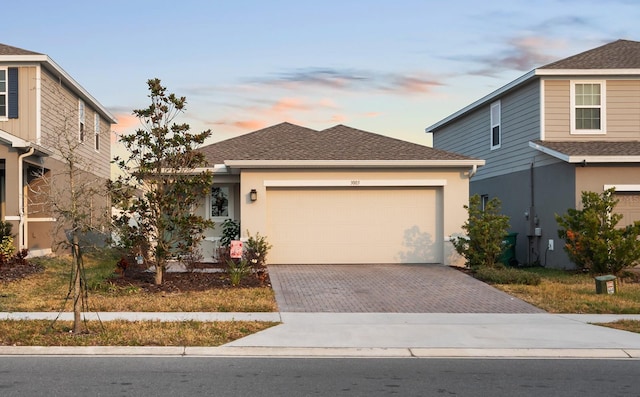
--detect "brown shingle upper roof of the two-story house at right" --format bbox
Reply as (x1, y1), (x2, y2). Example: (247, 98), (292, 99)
(539, 40), (640, 69)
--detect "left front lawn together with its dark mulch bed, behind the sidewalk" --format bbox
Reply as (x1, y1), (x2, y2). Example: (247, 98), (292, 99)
(0, 251), (277, 312)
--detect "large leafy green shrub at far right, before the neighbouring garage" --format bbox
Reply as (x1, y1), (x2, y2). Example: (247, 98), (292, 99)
(556, 188), (640, 274)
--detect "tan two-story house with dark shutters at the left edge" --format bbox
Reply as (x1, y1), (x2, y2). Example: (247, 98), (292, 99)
(0, 44), (116, 255)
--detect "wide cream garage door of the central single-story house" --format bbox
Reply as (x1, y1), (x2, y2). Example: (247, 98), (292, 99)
(267, 187), (443, 264)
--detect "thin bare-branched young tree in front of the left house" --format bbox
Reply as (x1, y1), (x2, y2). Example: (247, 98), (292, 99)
(28, 106), (109, 333)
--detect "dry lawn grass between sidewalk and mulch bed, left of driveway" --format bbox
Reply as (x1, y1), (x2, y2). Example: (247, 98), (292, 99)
(0, 253), (277, 312)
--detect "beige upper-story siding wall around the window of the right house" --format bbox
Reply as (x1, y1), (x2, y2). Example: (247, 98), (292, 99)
(543, 78), (640, 141)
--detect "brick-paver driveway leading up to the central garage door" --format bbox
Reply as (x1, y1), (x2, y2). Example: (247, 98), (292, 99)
(269, 264), (543, 313)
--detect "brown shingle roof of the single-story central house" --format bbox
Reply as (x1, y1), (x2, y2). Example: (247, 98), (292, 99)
(199, 123), (472, 165)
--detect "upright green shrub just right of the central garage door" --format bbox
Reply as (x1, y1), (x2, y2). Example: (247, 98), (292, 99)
(451, 194), (509, 269)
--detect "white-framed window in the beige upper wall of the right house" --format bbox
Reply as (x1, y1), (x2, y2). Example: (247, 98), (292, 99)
(571, 81), (606, 134)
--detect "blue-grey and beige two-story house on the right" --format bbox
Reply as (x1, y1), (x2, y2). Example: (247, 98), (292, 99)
(426, 40), (640, 268)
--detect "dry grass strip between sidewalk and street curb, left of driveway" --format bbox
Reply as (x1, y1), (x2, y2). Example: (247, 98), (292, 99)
(0, 320), (276, 346)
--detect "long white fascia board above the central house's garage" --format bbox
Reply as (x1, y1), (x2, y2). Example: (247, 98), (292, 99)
(225, 159), (485, 168)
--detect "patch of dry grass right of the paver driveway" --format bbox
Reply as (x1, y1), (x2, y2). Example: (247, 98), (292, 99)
(494, 268), (640, 314)
